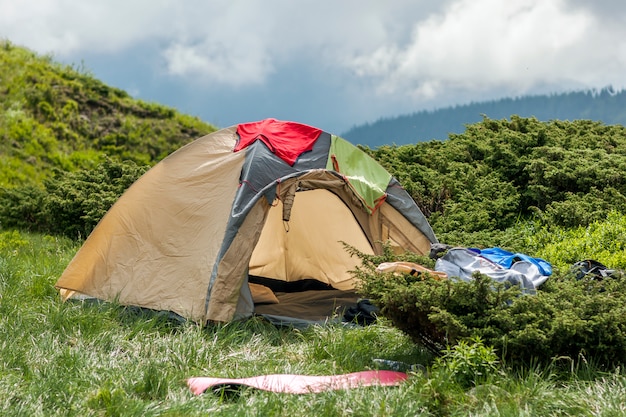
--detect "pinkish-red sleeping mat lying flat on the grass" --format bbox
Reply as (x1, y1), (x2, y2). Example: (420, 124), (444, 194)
(187, 371), (408, 395)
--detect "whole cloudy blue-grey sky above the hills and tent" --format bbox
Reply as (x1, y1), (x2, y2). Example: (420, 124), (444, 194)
(0, 0), (626, 134)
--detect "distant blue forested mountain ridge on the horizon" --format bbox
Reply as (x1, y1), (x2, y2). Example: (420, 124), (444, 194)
(341, 87), (626, 148)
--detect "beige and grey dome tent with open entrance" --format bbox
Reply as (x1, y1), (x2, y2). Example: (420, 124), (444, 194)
(56, 119), (437, 323)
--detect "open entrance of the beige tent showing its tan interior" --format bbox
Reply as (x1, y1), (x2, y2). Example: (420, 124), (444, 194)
(244, 189), (374, 321)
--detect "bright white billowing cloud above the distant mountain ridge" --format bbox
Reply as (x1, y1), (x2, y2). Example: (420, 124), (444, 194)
(345, 0), (626, 100)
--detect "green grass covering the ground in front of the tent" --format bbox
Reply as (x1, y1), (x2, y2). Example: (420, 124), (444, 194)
(0, 231), (626, 416)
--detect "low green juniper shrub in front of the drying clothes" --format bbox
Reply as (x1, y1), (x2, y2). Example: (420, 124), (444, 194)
(356, 245), (626, 366)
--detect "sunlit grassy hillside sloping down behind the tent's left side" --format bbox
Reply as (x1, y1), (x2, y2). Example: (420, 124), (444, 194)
(0, 41), (215, 187)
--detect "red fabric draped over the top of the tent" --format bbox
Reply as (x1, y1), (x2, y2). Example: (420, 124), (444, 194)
(234, 119), (322, 166)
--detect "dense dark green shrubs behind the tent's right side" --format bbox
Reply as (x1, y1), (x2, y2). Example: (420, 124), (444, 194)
(369, 115), (626, 233)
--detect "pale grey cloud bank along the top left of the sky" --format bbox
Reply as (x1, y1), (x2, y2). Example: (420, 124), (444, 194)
(0, 0), (445, 87)
